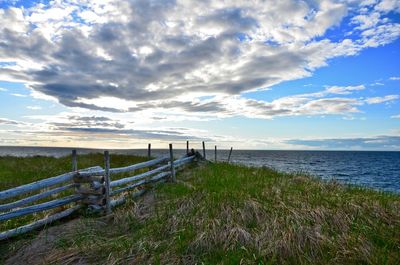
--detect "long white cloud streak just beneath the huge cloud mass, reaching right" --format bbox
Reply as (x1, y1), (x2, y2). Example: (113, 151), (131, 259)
(115, 85), (398, 119)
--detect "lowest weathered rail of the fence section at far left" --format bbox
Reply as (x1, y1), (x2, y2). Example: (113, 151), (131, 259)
(0, 205), (82, 240)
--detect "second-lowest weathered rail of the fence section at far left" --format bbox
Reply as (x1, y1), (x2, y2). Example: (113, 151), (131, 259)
(0, 194), (84, 221)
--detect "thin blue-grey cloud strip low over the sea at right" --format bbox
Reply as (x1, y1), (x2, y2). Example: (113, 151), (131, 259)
(286, 135), (400, 150)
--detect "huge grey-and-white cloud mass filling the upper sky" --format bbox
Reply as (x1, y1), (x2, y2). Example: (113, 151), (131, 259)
(0, 0), (400, 117)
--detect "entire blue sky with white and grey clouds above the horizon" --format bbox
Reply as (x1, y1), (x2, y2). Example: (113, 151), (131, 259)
(0, 0), (400, 148)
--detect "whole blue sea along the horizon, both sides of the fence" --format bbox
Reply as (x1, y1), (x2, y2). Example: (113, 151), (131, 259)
(0, 146), (400, 193)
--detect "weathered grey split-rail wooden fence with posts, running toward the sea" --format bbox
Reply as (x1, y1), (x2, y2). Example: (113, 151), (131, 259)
(0, 142), (205, 240)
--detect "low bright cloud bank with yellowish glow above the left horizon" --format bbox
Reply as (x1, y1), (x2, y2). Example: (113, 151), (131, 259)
(0, 113), (210, 148)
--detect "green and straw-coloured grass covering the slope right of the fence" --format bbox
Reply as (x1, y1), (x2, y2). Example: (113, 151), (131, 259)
(2, 156), (400, 264)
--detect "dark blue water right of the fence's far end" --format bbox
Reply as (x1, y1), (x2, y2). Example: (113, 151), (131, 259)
(228, 151), (400, 193)
